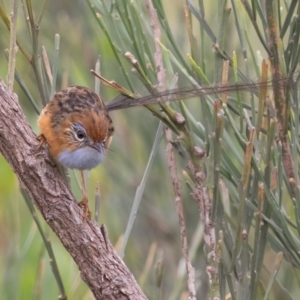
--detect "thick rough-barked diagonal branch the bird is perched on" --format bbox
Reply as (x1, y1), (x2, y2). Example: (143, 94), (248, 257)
(0, 79), (147, 300)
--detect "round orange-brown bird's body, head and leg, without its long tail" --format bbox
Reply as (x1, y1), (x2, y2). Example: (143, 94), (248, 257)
(38, 86), (114, 220)
